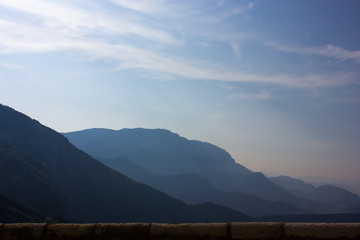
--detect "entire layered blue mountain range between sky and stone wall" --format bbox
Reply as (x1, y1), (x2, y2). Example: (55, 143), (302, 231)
(0, 105), (360, 223)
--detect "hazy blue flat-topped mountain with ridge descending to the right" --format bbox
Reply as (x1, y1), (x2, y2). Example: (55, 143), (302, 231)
(64, 128), (340, 213)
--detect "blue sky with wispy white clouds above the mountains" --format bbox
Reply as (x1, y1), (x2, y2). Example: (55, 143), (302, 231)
(0, 0), (360, 180)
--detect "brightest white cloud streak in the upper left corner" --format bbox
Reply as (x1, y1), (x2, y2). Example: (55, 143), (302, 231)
(0, 0), (179, 44)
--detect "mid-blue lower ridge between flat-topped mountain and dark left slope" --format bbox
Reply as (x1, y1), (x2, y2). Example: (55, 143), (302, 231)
(99, 157), (311, 216)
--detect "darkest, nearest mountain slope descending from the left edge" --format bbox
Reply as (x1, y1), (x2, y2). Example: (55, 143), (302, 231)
(0, 105), (250, 223)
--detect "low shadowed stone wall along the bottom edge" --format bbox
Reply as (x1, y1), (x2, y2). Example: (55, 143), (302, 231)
(0, 223), (360, 240)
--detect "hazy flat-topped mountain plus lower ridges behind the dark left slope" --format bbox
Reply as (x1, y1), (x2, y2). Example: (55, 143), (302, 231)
(64, 128), (360, 216)
